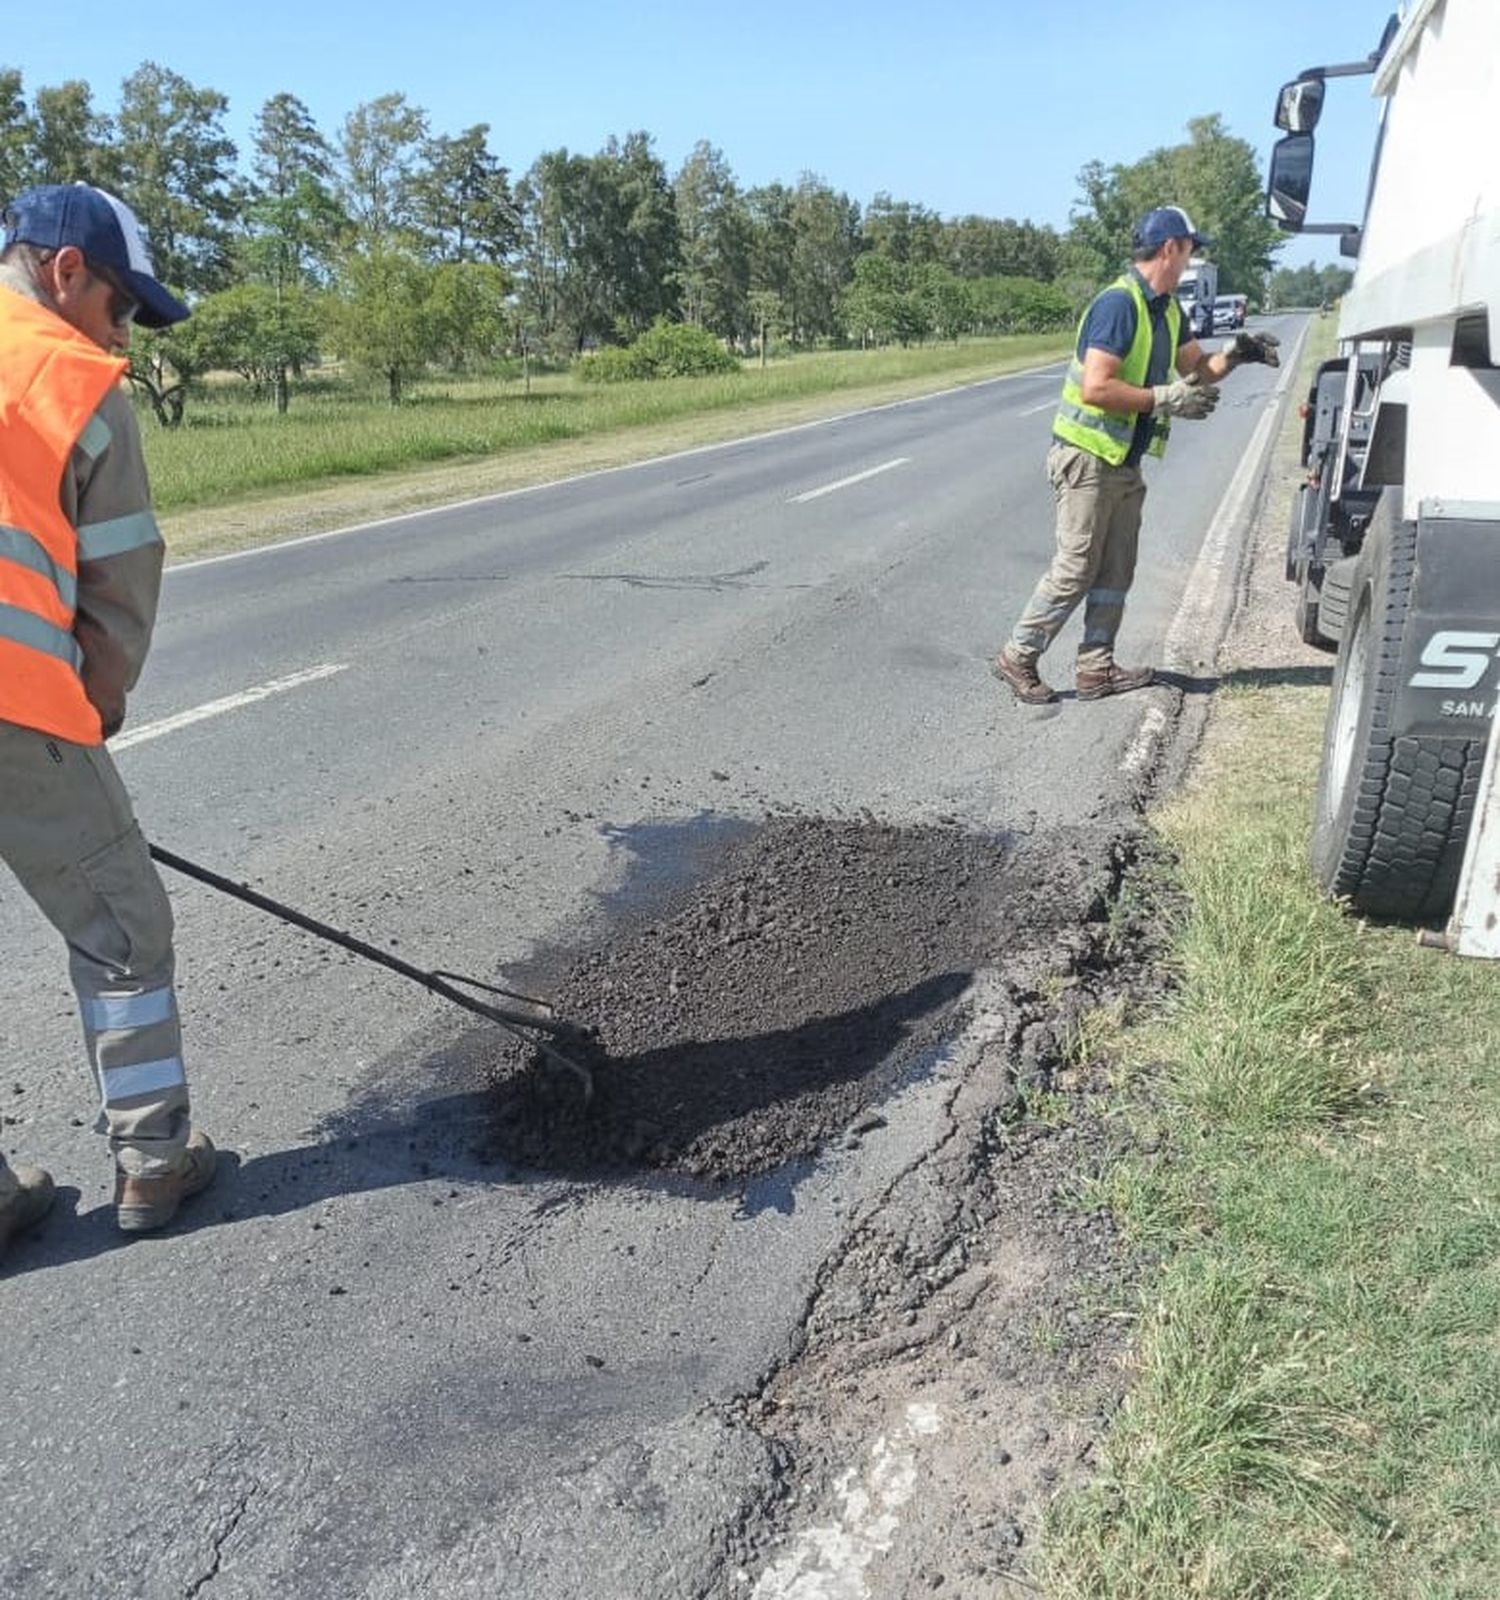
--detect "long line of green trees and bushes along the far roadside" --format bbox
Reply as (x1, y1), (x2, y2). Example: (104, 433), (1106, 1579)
(0, 62), (1276, 422)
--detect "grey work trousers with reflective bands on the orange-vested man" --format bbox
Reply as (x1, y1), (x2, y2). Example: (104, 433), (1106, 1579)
(0, 722), (189, 1192)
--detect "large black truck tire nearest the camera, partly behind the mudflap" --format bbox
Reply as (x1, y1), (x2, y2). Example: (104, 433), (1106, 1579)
(1311, 494), (1484, 922)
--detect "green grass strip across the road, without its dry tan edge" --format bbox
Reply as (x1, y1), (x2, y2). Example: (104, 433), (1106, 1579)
(142, 334), (1067, 512)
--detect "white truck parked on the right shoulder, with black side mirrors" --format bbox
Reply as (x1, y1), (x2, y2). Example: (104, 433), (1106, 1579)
(1267, 0), (1500, 923)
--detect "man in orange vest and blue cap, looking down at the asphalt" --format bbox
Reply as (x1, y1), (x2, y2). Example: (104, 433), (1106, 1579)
(0, 184), (214, 1254)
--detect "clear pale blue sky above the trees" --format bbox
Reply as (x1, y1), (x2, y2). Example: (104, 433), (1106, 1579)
(0, 0), (1394, 266)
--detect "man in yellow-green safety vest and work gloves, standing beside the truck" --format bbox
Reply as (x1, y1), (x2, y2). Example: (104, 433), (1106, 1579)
(993, 205), (1281, 706)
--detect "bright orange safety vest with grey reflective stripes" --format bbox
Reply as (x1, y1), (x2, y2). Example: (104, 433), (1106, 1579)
(0, 290), (126, 744)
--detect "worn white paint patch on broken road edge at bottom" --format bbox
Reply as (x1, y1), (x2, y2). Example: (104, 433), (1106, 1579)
(750, 1400), (942, 1600)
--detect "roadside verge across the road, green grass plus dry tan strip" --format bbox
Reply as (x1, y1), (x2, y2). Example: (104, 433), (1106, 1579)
(142, 334), (1068, 560)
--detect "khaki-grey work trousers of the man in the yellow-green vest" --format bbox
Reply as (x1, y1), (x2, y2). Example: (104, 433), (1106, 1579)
(1009, 443), (1147, 672)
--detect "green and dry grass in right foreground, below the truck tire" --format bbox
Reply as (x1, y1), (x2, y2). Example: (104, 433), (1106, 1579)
(1041, 686), (1500, 1600)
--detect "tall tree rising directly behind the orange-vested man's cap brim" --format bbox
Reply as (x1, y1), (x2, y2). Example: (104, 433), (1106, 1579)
(117, 61), (240, 290)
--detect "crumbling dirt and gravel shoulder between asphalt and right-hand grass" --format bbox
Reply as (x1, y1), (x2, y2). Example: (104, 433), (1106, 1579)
(700, 371), (1329, 1600)
